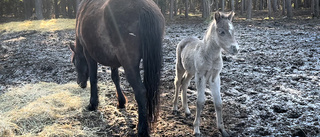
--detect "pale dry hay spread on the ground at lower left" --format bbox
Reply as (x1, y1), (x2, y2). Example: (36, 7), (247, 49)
(0, 83), (103, 137)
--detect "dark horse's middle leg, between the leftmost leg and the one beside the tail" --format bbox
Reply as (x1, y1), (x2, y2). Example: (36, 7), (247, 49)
(111, 68), (127, 108)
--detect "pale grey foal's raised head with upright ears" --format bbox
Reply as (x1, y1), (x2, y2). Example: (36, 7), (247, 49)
(212, 11), (239, 55)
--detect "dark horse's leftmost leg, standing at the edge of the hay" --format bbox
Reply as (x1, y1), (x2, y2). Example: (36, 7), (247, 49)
(85, 54), (99, 111)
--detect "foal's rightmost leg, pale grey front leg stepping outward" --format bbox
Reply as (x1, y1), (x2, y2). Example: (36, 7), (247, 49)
(209, 71), (229, 137)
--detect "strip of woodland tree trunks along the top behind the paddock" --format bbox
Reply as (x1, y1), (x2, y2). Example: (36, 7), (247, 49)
(0, 0), (320, 22)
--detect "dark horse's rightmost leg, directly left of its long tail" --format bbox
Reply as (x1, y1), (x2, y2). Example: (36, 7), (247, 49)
(123, 65), (150, 137)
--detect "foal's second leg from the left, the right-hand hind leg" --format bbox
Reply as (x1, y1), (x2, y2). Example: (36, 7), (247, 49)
(181, 72), (193, 117)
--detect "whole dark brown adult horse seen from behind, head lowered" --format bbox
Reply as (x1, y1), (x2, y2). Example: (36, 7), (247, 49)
(70, 0), (165, 136)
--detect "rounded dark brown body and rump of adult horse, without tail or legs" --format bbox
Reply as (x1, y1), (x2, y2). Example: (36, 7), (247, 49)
(76, 0), (162, 67)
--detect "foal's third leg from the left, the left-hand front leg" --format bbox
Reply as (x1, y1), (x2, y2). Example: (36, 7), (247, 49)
(193, 72), (207, 136)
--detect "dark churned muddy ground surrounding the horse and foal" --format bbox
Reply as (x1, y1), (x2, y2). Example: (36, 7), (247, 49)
(0, 20), (320, 136)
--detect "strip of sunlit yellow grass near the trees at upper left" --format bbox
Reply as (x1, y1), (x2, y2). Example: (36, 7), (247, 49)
(0, 19), (76, 32)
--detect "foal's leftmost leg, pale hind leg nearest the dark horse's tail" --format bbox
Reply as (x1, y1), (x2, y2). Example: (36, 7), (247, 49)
(172, 66), (185, 113)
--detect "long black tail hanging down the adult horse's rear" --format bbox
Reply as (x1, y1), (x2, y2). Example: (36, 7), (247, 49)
(139, 5), (165, 129)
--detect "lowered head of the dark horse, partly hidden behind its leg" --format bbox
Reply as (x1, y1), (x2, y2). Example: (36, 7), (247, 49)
(69, 43), (89, 88)
